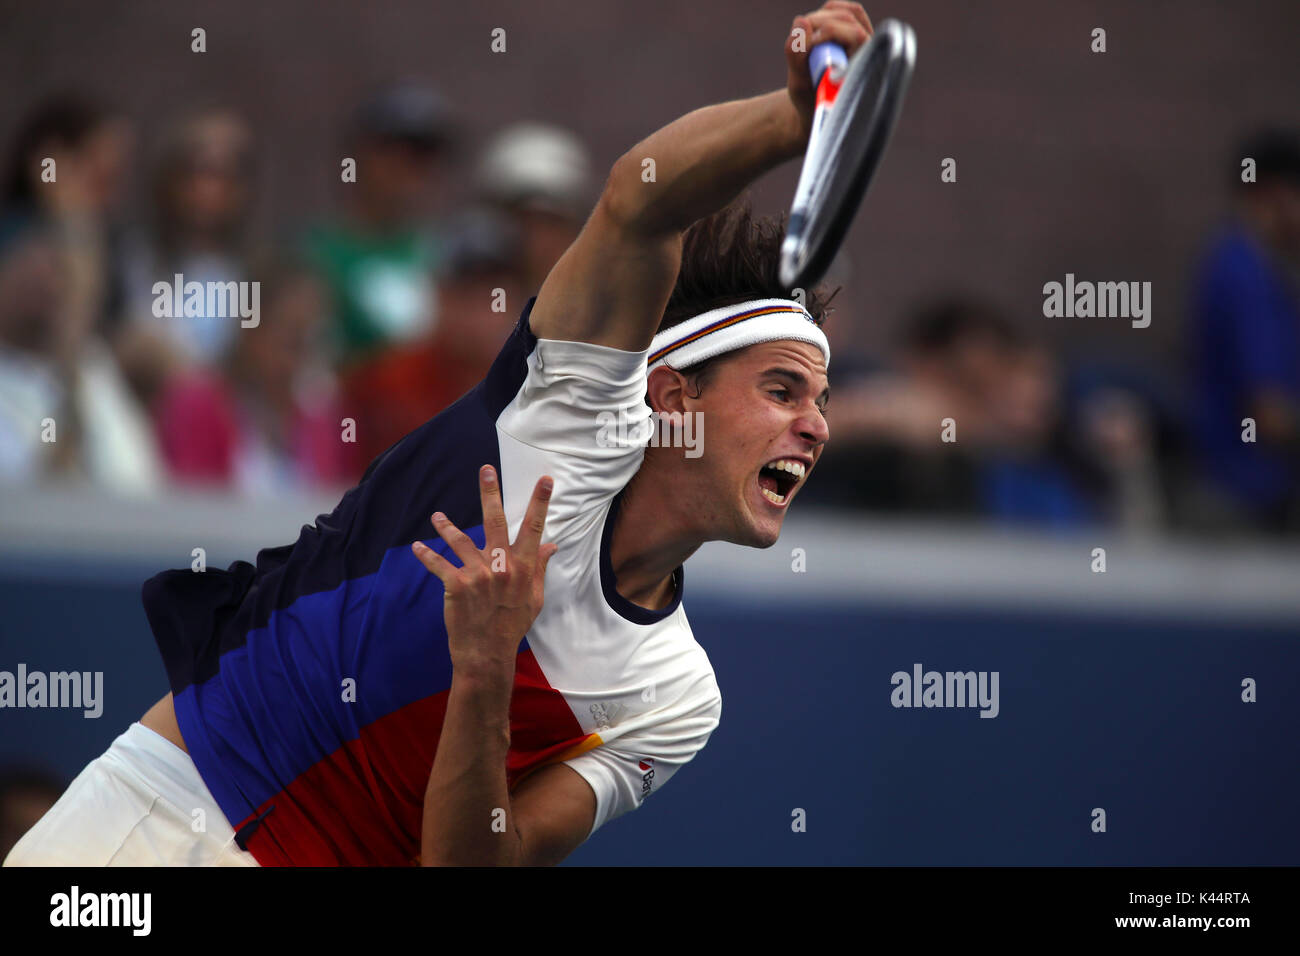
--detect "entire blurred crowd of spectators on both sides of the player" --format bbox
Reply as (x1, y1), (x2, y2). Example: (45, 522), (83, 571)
(0, 85), (1300, 533)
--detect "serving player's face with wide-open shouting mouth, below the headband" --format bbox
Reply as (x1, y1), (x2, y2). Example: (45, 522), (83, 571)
(679, 341), (831, 548)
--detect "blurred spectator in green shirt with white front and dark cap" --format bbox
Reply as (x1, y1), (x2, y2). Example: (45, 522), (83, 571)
(307, 86), (454, 365)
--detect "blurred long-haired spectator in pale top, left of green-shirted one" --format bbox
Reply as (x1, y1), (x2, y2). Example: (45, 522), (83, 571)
(117, 109), (254, 405)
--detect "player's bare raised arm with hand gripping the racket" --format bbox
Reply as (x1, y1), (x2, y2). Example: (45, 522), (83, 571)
(529, 0), (871, 351)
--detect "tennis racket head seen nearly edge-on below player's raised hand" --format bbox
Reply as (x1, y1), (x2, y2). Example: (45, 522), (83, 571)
(780, 20), (917, 289)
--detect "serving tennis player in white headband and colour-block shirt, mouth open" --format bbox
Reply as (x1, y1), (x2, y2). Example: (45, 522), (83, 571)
(7, 0), (871, 865)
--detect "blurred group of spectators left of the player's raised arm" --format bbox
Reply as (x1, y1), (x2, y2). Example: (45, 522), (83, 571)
(0, 86), (595, 494)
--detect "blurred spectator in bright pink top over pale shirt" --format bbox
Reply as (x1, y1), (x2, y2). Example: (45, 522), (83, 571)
(155, 252), (351, 494)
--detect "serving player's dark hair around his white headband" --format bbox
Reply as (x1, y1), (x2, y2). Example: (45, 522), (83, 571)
(658, 196), (840, 398)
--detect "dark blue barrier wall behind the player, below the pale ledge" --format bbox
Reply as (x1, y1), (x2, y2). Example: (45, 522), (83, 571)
(0, 559), (1300, 866)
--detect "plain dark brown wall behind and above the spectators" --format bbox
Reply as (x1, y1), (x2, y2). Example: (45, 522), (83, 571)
(0, 0), (1300, 377)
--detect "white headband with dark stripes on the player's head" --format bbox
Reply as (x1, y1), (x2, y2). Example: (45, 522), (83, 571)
(646, 299), (831, 372)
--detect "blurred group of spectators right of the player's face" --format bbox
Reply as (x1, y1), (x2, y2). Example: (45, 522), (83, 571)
(806, 129), (1300, 536)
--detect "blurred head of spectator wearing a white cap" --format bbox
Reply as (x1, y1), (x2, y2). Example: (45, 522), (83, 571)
(477, 122), (595, 295)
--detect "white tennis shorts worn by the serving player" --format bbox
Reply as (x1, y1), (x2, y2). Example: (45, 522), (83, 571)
(4, 722), (257, 866)
